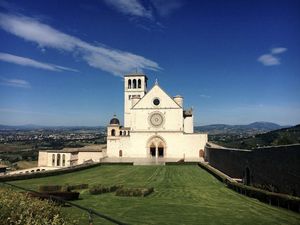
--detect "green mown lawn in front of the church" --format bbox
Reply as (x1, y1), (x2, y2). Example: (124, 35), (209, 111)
(7, 165), (300, 225)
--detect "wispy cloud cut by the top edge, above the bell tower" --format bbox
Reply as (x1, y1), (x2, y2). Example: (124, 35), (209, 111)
(104, 0), (153, 19)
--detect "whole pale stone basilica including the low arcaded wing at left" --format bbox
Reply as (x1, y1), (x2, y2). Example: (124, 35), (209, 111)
(38, 73), (207, 170)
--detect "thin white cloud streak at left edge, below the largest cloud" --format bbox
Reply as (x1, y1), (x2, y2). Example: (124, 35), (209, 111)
(0, 52), (78, 72)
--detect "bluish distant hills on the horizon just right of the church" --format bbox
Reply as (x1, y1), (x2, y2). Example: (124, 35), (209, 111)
(195, 122), (287, 135)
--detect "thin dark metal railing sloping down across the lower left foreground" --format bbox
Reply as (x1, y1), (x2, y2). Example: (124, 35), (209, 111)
(1, 182), (127, 225)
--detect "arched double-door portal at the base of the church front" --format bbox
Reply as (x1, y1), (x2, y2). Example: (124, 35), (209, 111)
(147, 136), (166, 158)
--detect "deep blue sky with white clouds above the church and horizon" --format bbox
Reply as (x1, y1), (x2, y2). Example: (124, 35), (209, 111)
(0, 0), (300, 126)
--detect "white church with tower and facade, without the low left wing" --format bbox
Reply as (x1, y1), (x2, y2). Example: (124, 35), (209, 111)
(106, 74), (207, 161)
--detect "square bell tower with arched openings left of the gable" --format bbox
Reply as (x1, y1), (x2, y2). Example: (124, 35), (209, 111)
(124, 73), (148, 127)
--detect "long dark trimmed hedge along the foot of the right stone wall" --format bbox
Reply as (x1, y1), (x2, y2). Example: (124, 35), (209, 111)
(198, 163), (300, 212)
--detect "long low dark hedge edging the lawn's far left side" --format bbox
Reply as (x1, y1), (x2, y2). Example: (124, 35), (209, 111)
(0, 163), (101, 182)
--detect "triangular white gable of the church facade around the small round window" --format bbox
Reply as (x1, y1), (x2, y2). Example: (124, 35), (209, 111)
(132, 83), (182, 109)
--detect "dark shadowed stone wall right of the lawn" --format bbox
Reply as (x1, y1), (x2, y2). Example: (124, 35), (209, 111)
(205, 144), (300, 196)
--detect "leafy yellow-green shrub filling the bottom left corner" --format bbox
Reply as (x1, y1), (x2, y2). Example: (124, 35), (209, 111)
(0, 189), (76, 225)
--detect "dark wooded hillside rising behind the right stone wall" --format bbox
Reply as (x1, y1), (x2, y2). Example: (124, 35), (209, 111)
(218, 124), (300, 149)
